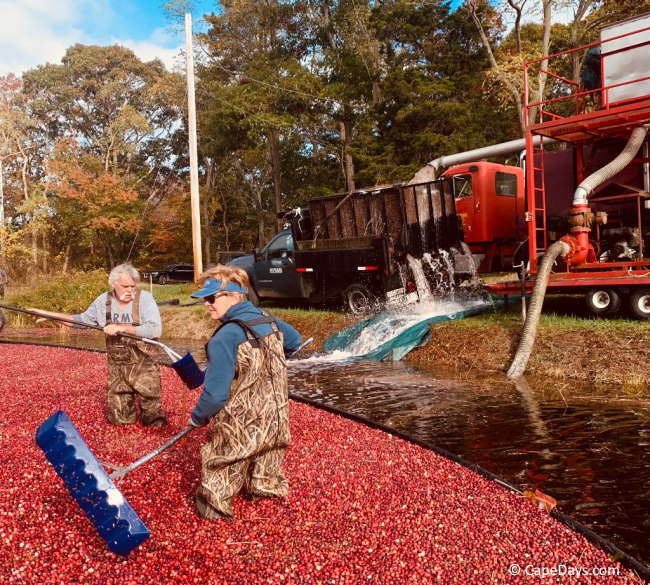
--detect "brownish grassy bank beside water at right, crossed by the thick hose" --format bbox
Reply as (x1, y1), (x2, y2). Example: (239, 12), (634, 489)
(407, 313), (650, 393)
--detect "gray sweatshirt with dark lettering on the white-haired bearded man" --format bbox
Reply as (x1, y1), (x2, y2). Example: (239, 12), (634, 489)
(72, 290), (162, 339)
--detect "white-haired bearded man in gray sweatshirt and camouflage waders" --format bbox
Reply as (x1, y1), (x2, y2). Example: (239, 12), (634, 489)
(33, 264), (167, 427)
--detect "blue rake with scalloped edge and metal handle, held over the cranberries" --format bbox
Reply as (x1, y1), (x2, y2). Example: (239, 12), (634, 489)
(36, 410), (193, 555)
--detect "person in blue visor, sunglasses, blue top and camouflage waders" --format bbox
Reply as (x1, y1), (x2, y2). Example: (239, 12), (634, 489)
(190, 265), (301, 520)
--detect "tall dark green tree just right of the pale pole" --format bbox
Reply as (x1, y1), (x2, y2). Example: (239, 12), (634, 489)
(199, 0), (330, 243)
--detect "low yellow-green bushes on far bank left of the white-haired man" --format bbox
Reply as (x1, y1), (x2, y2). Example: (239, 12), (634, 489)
(7, 270), (108, 313)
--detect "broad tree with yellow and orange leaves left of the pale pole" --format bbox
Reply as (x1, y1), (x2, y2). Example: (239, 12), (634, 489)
(24, 45), (182, 268)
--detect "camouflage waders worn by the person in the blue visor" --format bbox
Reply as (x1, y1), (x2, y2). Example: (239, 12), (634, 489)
(196, 317), (291, 518)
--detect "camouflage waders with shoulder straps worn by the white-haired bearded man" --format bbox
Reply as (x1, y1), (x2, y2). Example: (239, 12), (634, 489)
(106, 291), (165, 425)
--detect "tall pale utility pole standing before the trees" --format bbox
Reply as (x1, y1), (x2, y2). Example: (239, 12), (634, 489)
(185, 12), (203, 281)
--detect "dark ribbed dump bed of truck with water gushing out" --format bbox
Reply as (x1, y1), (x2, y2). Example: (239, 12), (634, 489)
(284, 179), (475, 313)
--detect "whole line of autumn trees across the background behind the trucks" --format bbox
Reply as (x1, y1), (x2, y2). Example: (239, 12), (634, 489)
(0, 0), (650, 277)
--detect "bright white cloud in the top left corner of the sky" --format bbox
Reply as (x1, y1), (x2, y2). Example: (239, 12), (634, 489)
(0, 0), (180, 75)
